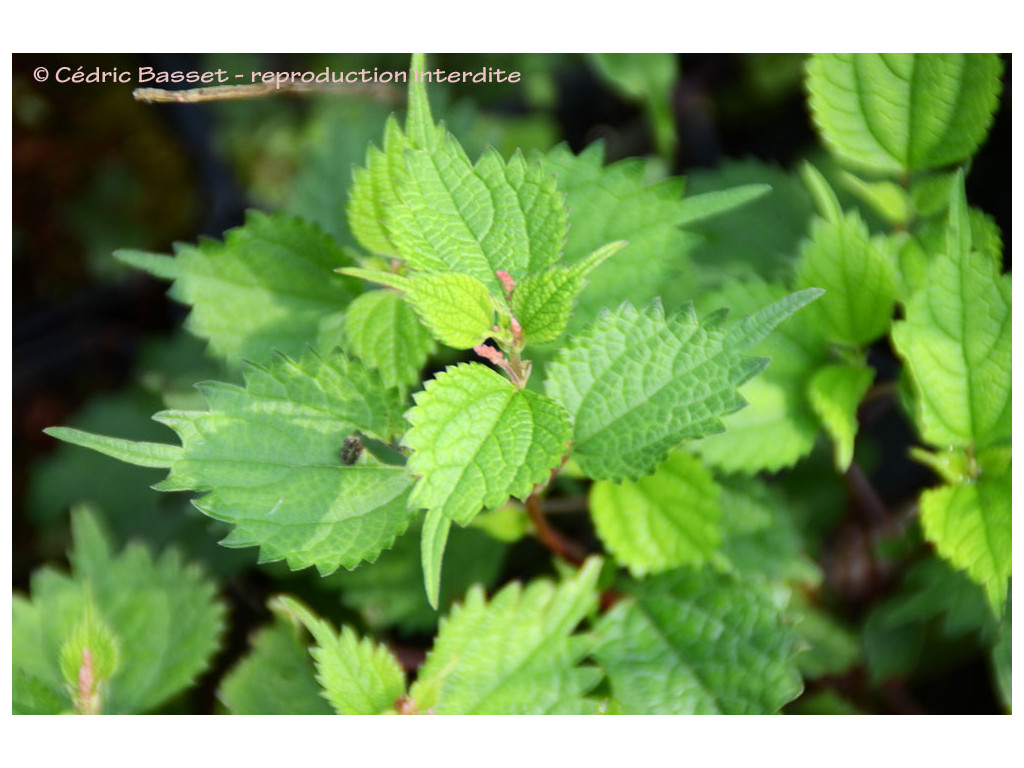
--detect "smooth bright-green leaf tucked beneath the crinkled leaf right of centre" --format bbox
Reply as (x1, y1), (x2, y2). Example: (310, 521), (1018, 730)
(590, 451), (722, 577)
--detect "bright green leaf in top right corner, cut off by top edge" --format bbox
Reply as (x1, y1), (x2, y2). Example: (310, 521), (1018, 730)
(807, 53), (1002, 174)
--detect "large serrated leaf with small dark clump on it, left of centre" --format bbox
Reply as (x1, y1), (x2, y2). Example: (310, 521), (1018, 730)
(47, 351), (413, 573)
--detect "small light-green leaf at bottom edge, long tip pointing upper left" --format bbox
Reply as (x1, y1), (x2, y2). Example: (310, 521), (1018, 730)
(274, 596), (406, 715)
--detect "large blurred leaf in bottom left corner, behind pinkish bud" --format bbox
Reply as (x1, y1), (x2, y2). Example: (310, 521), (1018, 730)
(12, 509), (224, 714)
